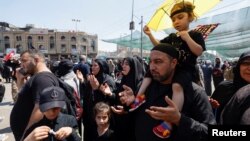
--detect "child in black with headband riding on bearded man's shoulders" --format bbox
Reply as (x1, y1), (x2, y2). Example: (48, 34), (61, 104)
(130, 1), (206, 138)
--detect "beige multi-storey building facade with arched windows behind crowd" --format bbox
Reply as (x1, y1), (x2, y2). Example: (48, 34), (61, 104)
(0, 22), (98, 60)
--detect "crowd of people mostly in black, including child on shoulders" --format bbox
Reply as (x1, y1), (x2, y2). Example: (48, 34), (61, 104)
(0, 2), (250, 141)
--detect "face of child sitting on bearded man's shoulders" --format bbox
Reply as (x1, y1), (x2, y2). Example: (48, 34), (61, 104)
(171, 12), (191, 31)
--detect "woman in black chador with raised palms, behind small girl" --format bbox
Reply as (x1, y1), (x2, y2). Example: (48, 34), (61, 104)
(83, 59), (116, 141)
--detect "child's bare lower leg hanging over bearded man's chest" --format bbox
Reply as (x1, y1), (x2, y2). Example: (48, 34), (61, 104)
(172, 83), (184, 111)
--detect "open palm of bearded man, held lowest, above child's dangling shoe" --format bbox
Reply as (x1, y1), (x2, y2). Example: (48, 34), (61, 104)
(146, 96), (181, 125)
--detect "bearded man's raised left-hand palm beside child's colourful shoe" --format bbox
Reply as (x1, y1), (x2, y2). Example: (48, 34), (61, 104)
(119, 85), (135, 106)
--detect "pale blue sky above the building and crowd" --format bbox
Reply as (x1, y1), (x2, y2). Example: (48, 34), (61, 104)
(0, 0), (249, 51)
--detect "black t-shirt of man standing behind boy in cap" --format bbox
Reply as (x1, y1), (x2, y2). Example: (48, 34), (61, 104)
(10, 72), (58, 141)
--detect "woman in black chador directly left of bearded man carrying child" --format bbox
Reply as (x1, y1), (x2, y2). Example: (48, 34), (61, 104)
(114, 57), (144, 141)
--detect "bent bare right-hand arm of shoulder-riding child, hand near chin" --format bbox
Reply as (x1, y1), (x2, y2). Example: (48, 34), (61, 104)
(178, 31), (203, 56)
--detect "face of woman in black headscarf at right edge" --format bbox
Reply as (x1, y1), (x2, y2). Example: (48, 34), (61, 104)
(240, 58), (250, 83)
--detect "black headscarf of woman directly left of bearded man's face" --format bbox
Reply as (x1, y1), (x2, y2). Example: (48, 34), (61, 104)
(121, 57), (144, 92)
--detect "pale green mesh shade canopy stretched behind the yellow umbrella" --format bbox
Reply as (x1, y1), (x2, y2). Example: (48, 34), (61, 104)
(104, 7), (250, 58)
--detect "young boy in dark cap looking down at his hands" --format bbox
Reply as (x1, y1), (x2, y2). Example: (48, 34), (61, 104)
(23, 86), (81, 141)
